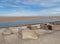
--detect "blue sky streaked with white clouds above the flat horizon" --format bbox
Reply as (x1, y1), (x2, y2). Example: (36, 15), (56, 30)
(0, 0), (60, 16)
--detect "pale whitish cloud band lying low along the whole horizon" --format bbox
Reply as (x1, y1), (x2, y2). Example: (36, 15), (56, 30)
(0, 8), (60, 16)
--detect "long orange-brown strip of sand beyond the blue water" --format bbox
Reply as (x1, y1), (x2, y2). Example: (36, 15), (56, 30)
(0, 16), (60, 22)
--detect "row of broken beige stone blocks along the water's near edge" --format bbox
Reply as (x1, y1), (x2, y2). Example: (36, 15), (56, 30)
(0, 23), (60, 39)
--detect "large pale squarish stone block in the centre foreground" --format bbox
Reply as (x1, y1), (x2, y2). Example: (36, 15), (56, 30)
(22, 29), (38, 39)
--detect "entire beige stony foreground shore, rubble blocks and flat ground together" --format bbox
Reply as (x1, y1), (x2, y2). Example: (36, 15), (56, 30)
(0, 23), (60, 44)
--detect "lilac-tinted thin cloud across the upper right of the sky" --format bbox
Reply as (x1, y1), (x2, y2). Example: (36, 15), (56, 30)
(16, 0), (60, 7)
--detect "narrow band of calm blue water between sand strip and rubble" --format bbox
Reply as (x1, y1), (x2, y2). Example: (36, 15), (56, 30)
(0, 20), (59, 28)
